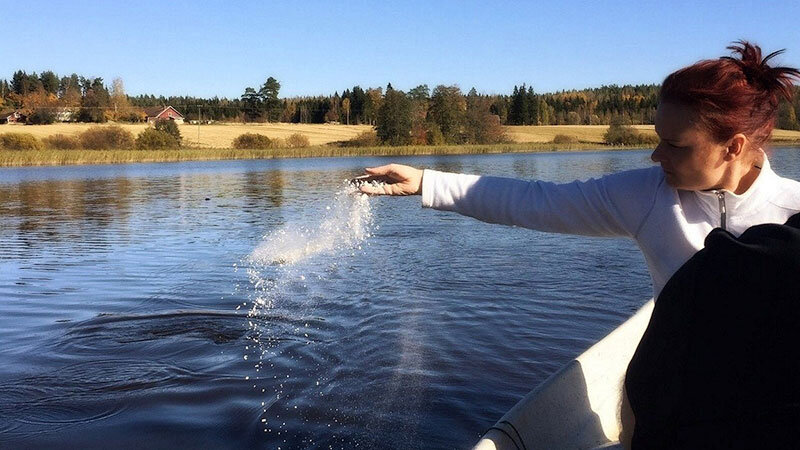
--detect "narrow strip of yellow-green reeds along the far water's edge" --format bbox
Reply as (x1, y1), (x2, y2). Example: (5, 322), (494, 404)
(0, 141), (800, 167)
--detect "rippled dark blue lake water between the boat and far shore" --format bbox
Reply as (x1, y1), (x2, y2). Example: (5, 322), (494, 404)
(0, 149), (800, 448)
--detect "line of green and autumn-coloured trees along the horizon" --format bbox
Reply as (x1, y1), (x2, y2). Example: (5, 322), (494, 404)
(0, 70), (800, 137)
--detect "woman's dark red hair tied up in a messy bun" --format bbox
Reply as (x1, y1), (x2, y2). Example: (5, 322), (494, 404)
(659, 41), (800, 146)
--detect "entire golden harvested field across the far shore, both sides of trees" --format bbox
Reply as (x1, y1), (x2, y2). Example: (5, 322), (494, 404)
(6, 123), (800, 148)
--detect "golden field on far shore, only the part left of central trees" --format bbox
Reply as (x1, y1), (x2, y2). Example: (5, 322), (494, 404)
(9, 123), (372, 148)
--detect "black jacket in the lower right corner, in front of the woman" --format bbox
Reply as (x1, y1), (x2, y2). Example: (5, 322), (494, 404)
(625, 214), (800, 449)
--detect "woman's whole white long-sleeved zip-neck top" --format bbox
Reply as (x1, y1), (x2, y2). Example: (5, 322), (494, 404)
(422, 158), (800, 297)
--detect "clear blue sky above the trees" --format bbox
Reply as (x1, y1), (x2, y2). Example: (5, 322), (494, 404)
(0, 0), (800, 97)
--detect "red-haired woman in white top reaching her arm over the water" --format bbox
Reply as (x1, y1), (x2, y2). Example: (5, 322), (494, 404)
(361, 41), (800, 298)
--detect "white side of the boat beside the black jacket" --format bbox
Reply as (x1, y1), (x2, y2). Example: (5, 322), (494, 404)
(473, 299), (654, 450)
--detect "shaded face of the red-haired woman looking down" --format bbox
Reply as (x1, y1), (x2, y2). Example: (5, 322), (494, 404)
(650, 102), (728, 191)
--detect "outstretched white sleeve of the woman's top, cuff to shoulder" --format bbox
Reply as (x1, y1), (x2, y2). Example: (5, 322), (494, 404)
(422, 167), (664, 237)
